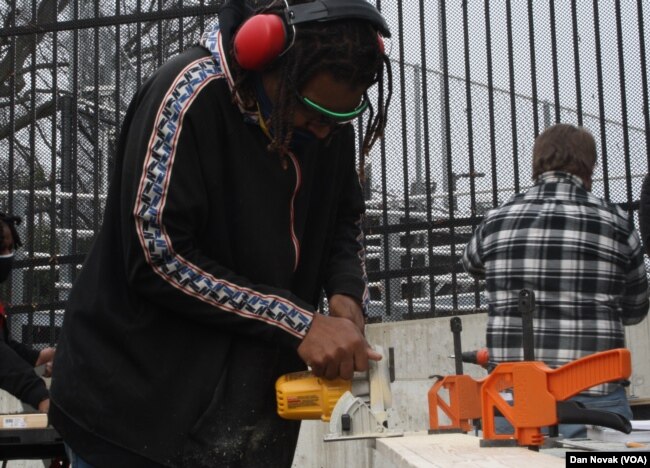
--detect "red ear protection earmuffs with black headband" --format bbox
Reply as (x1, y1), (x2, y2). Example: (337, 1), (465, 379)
(233, 0), (390, 71)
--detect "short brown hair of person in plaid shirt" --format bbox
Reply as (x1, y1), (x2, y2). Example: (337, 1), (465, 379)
(533, 124), (597, 181)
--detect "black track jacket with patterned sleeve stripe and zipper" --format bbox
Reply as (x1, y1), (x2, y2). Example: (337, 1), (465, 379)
(50, 19), (367, 466)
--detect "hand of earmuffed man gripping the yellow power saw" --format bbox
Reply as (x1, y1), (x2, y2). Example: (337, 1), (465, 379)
(298, 314), (382, 380)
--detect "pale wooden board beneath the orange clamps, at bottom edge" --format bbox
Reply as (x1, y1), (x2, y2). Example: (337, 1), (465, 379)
(376, 433), (565, 468)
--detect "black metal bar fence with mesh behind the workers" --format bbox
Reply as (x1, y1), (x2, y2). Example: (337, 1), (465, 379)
(0, 0), (650, 346)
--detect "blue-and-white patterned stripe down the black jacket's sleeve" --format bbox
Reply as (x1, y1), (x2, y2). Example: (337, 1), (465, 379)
(133, 57), (313, 338)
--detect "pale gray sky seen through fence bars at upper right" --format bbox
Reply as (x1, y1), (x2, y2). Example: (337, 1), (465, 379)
(372, 0), (650, 208)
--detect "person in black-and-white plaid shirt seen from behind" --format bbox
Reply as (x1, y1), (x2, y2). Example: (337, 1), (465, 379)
(462, 124), (648, 437)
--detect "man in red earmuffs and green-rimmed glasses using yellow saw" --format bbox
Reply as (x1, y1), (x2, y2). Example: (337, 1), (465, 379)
(50, 0), (390, 468)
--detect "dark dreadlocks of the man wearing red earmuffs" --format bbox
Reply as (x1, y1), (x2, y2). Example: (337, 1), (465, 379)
(231, 0), (392, 182)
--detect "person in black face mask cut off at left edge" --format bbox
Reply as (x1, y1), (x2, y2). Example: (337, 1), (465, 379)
(0, 213), (54, 413)
